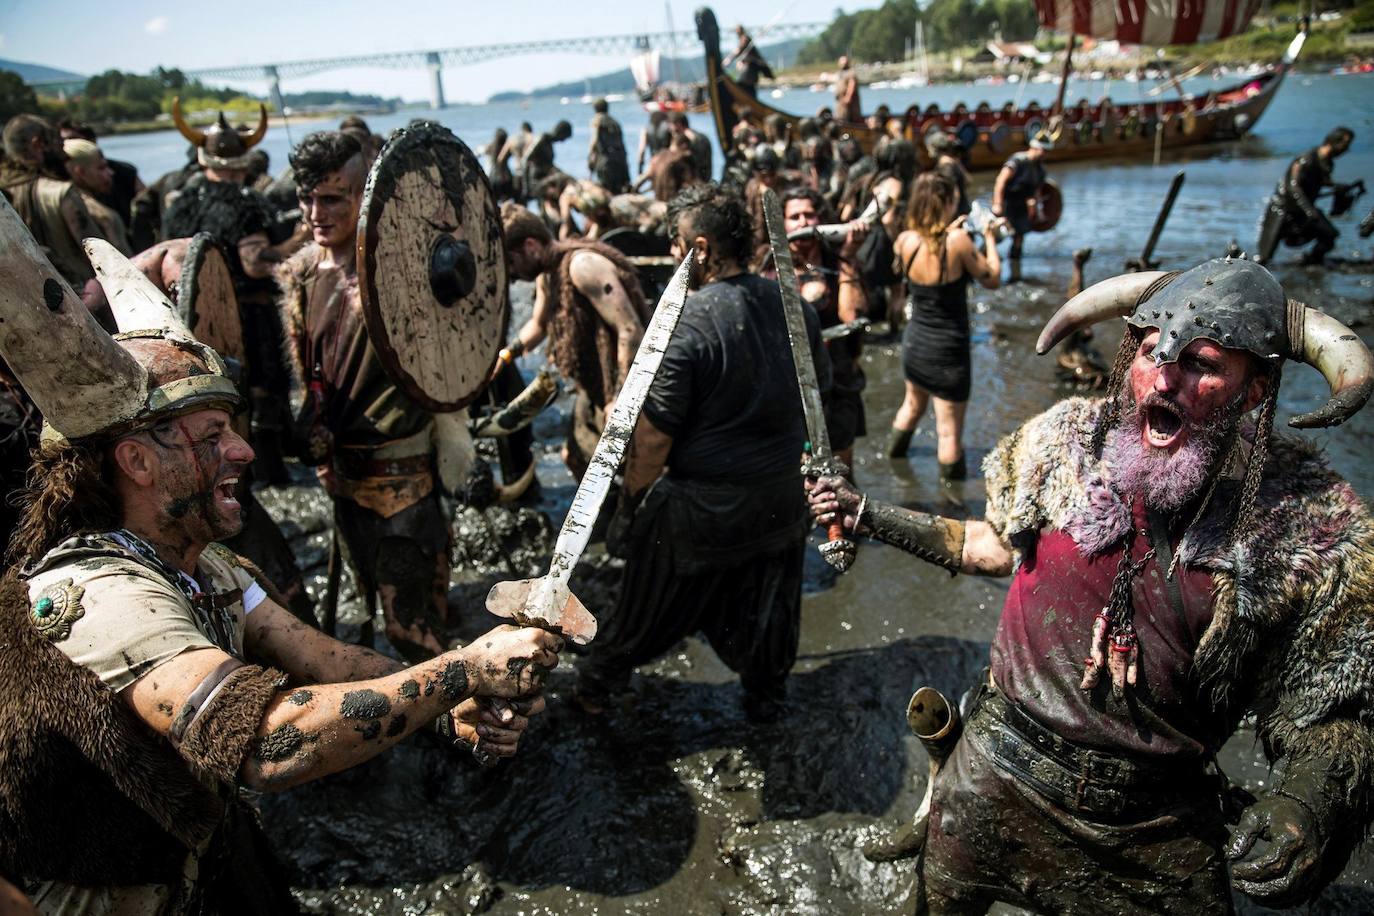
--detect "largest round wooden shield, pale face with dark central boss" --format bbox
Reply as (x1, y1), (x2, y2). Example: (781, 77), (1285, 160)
(357, 121), (510, 413)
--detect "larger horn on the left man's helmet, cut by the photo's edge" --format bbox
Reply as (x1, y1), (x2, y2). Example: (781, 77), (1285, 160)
(0, 198), (148, 439)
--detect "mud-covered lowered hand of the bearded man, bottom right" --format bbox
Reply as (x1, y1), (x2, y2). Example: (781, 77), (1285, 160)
(1226, 794), (1322, 908)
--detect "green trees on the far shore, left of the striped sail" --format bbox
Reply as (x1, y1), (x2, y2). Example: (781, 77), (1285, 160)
(797, 0), (1036, 65)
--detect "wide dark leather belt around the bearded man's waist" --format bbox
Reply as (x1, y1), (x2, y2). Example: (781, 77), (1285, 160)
(969, 687), (1216, 818)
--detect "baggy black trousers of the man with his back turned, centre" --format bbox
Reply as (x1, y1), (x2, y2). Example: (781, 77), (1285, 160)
(578, 481), (805, 700)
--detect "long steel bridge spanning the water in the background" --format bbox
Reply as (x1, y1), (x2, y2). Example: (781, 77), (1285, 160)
(32, 22), (827, 111)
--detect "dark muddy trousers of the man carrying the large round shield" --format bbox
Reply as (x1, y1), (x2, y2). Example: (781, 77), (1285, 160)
(334, 493), (449, 662)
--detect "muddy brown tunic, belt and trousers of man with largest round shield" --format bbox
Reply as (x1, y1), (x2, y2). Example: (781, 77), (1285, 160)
(279, 243), (449, 658)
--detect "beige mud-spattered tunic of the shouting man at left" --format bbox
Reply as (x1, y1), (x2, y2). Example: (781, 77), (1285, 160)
(23, 531), (267, 916)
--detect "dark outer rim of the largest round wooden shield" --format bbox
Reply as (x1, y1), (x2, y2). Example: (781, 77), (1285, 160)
(356, 121), (511, 413)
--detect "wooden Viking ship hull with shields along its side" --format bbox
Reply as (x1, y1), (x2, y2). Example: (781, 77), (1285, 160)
(697, 8), (1303, 170)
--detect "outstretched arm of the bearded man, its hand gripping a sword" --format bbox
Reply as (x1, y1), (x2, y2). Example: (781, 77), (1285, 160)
(805, 477), (1013, 575)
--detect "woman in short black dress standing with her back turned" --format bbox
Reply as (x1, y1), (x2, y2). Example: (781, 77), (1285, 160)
(888, 172), (1002, 481)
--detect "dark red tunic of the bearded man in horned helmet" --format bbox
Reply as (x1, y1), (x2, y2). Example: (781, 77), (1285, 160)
(992, 503), (1227, 757)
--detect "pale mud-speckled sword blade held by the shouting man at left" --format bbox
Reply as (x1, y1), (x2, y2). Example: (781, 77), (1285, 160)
(525, 253), (692, 625)
